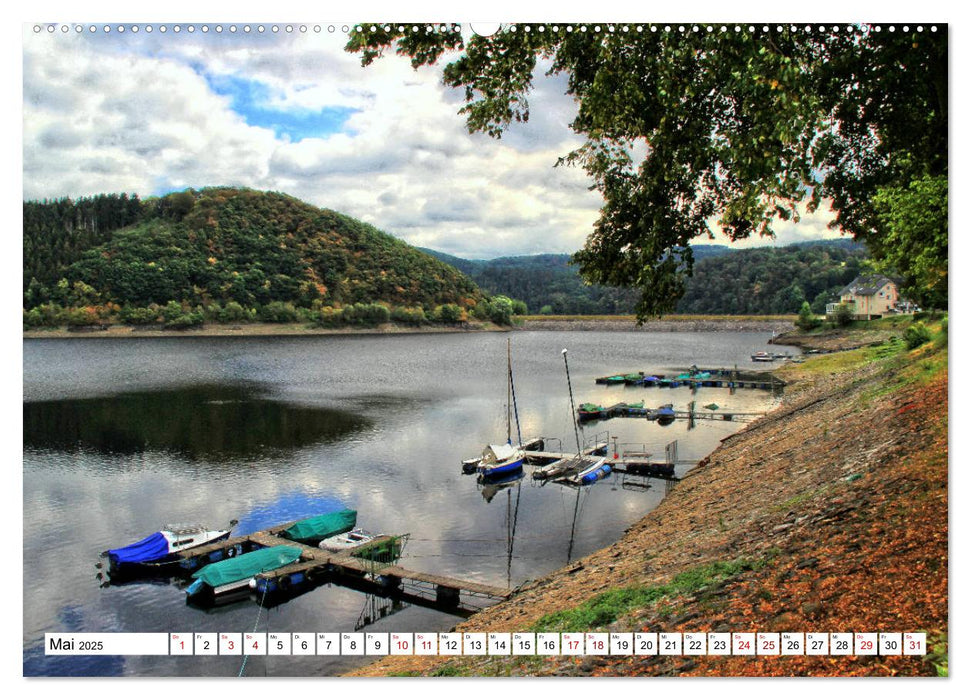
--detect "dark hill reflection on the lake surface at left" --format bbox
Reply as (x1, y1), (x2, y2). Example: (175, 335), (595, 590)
(24, 387), (371, 461)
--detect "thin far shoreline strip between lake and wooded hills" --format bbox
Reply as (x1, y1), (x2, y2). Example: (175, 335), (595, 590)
(22, 316), (793, 340)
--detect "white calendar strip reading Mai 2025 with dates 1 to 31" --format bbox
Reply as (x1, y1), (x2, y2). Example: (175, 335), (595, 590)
(44, 632), (927, 659)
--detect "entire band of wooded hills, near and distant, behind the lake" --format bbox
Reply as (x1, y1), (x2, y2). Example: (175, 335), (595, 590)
(23, 188), (865, 328)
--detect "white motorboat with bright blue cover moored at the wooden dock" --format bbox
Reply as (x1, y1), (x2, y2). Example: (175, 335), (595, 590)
(101, 520), (236, 578)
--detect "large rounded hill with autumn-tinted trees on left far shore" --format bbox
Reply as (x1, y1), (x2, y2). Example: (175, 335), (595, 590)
(24, 188), (483, 326)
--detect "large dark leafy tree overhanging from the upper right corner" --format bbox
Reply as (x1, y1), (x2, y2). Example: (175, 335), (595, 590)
(347, 24), (948, 319)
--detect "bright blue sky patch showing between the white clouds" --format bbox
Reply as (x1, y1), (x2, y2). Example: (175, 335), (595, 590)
(203, 73), (358, 141)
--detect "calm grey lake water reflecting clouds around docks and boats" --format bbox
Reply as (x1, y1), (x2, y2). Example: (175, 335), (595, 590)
(23, 332), (796, 676)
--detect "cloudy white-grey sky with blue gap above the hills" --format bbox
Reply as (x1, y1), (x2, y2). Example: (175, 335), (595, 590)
(23, 23), (837, 258)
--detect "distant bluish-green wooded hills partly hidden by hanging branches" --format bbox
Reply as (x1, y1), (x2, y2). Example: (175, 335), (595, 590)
(427, 239), (865, 314)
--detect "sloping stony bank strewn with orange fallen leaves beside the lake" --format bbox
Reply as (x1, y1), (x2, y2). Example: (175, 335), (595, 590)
(354, 320), (948, 676)
